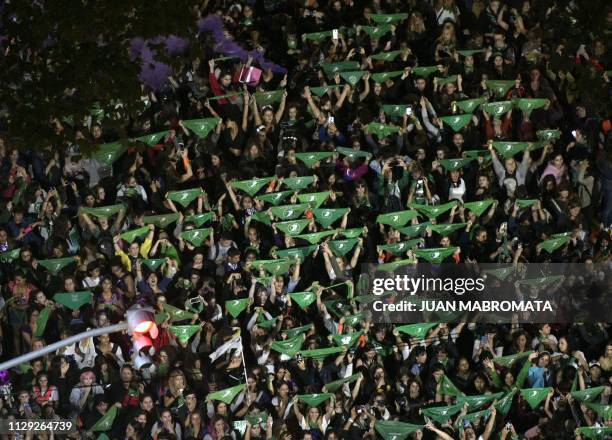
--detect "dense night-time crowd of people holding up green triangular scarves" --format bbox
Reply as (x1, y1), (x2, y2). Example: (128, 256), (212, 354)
(0, 0), (612, 440)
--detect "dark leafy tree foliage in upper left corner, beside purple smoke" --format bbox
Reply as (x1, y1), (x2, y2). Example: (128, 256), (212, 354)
(0, 0), (196, 148)
